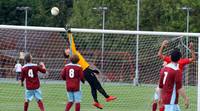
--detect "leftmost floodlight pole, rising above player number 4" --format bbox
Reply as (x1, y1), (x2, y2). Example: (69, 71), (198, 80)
(16, 7), (31, 53)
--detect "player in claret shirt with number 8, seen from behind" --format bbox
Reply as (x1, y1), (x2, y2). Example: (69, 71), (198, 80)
(62, 55), (84, 111)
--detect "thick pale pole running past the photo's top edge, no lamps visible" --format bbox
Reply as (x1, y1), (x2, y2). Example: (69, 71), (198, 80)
(133, 0), (140, 86)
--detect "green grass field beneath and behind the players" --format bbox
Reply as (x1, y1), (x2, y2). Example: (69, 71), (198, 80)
(0, 82), (197, 111)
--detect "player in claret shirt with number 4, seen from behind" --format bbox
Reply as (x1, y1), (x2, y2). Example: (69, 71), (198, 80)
(21, 54), (46, 111)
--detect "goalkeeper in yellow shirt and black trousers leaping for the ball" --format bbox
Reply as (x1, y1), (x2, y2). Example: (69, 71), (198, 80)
(64, 31), (116, 109)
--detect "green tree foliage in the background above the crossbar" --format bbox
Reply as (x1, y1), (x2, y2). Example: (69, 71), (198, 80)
(0, 0), (200, 32)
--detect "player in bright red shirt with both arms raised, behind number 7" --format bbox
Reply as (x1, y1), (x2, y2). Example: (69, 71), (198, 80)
(152, 40), (196, 111)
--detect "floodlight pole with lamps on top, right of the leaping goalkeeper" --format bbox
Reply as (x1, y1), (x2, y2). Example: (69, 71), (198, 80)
(93, 7), (108, 78)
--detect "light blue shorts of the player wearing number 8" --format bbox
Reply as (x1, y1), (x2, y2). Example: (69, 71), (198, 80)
(67, 91), (82, 103)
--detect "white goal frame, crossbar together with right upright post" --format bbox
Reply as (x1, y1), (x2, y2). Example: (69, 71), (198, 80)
(0, 25), (200, 111)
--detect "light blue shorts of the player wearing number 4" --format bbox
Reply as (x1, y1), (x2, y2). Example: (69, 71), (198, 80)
(25, 89), (42, 101)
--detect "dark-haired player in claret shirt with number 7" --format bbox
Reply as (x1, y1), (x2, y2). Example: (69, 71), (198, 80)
(159, 49), (189, 111)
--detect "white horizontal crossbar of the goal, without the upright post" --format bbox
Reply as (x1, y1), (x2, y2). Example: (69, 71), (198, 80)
(0, 25), (200, 37)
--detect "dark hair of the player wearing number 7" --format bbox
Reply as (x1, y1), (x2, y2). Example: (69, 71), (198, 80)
(171, 48), (182, 62)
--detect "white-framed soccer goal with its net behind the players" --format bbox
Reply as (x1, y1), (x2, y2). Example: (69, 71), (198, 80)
(0, 25), (200, 111)
